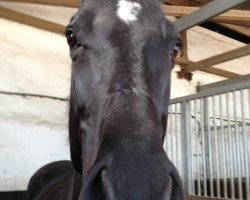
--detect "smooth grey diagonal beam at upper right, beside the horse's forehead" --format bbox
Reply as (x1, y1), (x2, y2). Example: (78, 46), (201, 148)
(175, 0), (248, 32)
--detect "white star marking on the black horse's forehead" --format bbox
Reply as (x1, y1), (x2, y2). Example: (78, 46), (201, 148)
(117, 0), (141, 24)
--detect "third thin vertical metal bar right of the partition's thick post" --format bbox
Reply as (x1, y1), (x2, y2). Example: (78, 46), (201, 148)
(206, 98), (214, 197)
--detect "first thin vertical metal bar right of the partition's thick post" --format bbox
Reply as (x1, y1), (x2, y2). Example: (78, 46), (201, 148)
(194, 99), (201, 196)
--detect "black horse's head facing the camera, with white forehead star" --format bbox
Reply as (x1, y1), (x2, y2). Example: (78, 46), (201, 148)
(27, 0), (184, 200)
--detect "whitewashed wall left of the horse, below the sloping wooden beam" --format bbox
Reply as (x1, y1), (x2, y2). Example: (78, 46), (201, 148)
(0, 18), (70, 191)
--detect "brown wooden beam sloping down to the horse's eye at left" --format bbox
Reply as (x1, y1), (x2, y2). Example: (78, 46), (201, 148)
(0, 7), (65, 34)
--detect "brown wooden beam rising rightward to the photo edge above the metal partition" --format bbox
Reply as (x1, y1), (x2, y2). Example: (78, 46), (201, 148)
(187, 44), (250, 72)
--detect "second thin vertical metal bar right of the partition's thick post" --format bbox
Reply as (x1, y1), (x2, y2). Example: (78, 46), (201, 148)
(200, 98), (207, 196)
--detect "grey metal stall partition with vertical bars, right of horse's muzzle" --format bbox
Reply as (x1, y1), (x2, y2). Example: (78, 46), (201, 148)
(164, 75), (250, 200)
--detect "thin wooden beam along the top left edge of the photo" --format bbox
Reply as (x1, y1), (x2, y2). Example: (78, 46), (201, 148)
(0, 0), (81, 8)
